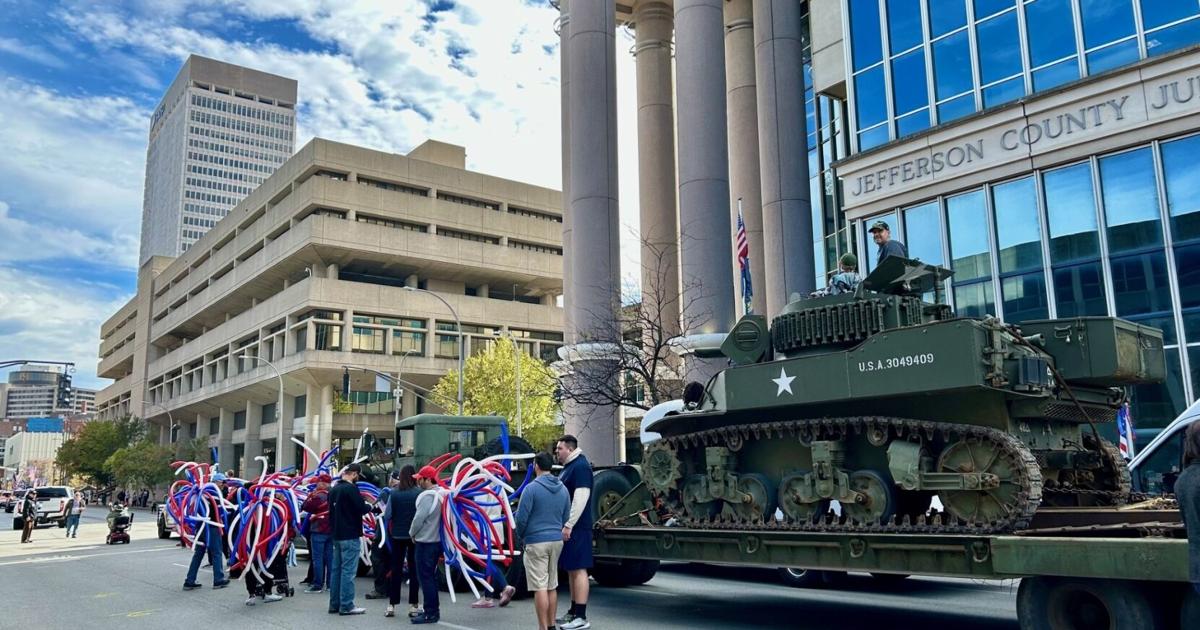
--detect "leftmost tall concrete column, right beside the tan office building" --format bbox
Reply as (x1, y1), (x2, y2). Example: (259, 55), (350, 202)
(565, 0), (620, 464)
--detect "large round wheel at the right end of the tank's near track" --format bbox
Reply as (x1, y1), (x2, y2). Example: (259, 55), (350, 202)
(937, 437), (1026, 523)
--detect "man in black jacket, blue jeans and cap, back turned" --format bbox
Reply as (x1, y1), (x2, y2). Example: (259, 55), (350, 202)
(329, 463), (371, 614)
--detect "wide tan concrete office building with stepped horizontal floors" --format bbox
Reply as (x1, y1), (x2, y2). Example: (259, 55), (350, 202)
(97, 139), (563, 474)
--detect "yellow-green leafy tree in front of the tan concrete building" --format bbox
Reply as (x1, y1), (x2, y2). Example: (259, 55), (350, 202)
(430, 337), (560, 449)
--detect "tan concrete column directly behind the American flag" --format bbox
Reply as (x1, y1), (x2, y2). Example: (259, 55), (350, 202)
(725, 0), (767, 314)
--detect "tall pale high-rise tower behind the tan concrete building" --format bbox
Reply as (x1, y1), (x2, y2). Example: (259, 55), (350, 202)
(139, 55), (296, 263)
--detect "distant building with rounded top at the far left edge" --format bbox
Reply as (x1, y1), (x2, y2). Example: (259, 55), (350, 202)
(0, 365), (96, 420)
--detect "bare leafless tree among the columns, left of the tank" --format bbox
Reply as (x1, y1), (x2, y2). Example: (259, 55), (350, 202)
(559, 235), (707, 410)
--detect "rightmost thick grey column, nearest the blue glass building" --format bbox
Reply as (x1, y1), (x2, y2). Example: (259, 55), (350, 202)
(754, 0), (816, 317)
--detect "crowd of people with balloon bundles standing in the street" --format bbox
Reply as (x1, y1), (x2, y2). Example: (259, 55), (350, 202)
(175, 436), (593, 630)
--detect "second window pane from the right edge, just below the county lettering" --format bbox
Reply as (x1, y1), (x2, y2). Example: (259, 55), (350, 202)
(1100, 148), (1163, 252)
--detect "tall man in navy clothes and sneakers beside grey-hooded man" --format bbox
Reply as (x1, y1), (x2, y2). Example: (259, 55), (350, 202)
(554, 436), (593, 630)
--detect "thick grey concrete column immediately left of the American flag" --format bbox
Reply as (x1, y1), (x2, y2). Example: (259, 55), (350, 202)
(674, 0), (733, 383)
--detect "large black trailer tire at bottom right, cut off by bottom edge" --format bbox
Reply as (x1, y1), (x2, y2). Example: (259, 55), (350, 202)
(1016, 577), (1166, 630)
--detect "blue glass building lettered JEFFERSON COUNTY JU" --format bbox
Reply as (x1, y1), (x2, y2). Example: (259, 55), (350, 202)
(812, 0), (1200, 427)
